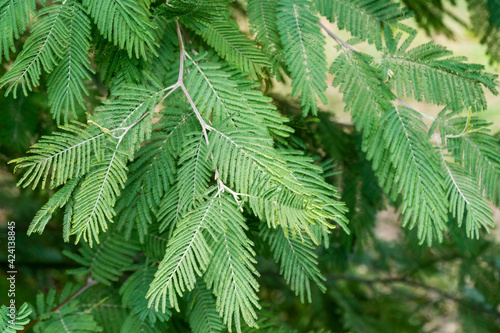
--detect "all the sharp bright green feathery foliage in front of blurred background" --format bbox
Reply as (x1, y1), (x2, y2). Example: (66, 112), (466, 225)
(0, 0), (500, 332)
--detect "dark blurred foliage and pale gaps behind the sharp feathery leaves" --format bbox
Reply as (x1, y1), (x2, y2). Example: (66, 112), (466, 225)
(0, 0), (500, 333)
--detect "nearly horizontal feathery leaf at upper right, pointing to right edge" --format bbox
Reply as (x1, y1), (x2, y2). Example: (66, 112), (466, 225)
(382, 38), (498, 111)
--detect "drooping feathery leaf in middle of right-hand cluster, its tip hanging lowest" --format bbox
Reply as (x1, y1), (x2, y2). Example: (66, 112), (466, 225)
(383, 106), (448, 244)
